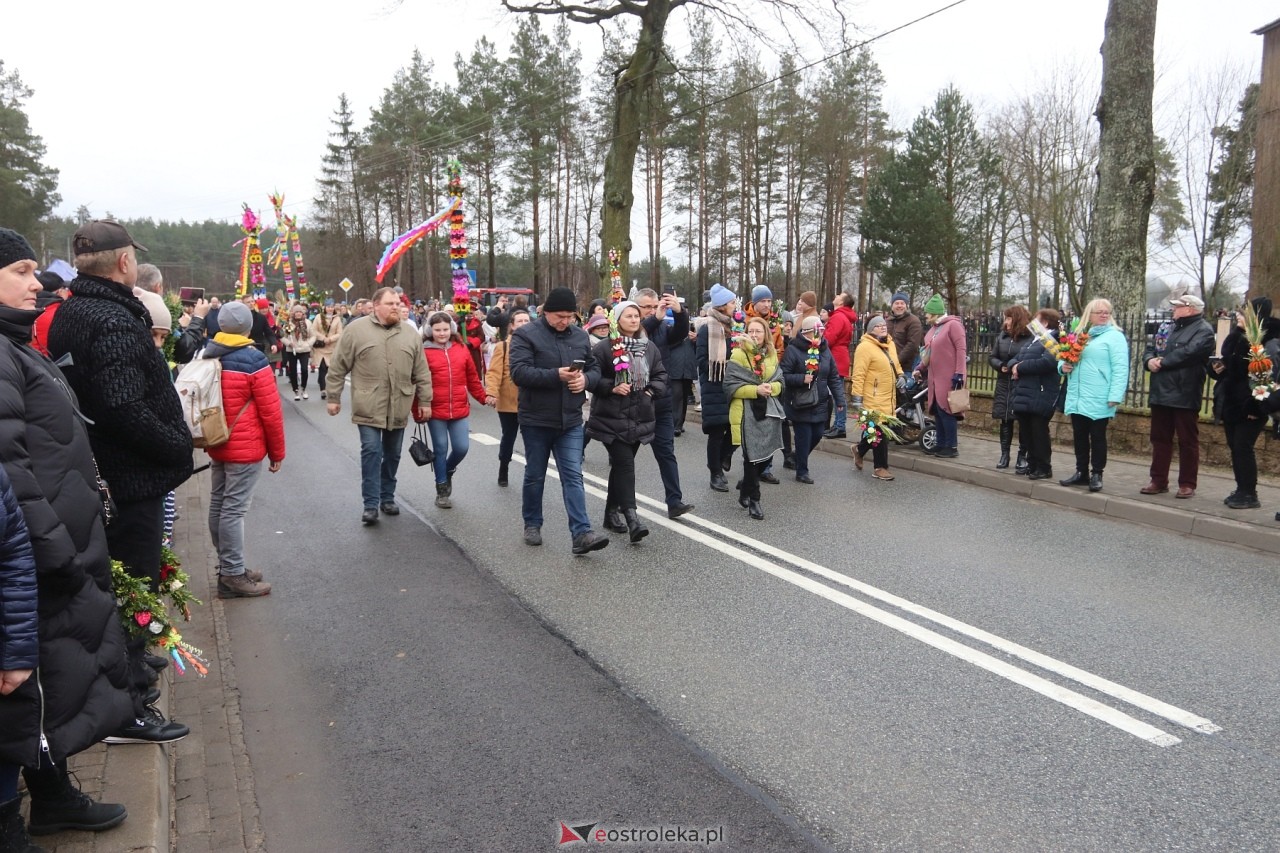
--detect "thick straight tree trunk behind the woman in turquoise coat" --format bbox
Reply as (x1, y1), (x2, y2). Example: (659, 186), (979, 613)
(1084, 0), (1156, 314)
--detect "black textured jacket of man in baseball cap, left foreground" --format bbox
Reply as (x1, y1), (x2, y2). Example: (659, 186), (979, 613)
(49, 275), (192, 501)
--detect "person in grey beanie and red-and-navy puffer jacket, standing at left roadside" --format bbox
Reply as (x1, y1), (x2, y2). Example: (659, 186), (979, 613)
(205, 302), (284, 598)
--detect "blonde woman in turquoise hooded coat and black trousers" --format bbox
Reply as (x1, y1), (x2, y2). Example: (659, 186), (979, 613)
(1059, 300), (1129, 492)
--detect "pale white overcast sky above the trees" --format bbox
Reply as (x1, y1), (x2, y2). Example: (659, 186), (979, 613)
(0, 0), (1280, 233)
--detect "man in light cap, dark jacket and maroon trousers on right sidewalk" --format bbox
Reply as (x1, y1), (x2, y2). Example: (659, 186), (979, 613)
(1138, 293), (1215, 498)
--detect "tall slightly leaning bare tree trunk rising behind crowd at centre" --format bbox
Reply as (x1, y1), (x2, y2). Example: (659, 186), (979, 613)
(599, 0), (671, 295)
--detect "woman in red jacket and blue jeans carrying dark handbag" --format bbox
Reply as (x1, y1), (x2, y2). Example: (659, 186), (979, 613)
(424, 311), (485, 510)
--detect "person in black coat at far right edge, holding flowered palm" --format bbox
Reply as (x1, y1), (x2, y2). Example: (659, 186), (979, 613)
(1210, 296), (1280, 510)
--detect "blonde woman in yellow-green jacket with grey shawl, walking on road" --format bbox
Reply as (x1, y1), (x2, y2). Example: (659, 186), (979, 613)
(724, 316), (785, 520)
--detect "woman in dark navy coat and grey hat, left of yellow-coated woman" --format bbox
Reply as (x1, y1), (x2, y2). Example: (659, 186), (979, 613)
(780, 315), (845, 485)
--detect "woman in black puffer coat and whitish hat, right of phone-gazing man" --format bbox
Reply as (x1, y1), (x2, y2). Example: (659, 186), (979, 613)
(586, 302), (667, 542)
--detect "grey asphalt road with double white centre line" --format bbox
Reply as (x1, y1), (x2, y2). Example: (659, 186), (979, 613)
(229, 381), (1280, 852)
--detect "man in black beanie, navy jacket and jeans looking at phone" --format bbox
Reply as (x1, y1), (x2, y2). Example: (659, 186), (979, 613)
(508, 287), (609, 555)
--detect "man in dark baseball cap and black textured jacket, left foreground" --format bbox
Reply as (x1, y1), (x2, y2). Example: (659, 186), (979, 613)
(49, 220), (192, 743)
